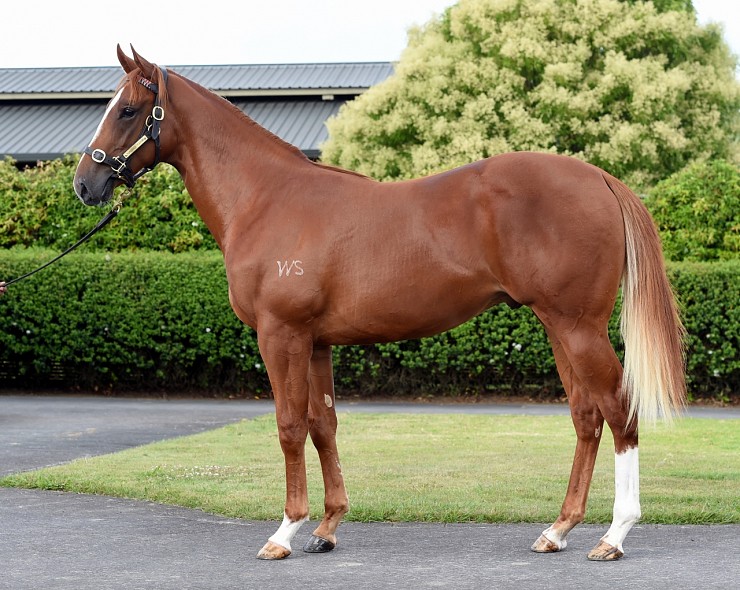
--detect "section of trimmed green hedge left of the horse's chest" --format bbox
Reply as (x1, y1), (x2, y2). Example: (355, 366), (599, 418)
(0, 249), (266, 391)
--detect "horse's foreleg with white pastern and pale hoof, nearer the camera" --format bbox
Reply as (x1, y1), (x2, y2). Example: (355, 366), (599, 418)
(257, 328), (312, 559)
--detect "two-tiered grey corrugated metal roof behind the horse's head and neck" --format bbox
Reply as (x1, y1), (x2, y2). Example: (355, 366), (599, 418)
(0, 63), (393, 162)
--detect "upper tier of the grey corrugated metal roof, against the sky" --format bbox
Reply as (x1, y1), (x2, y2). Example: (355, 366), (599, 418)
(0, 62), (393, 98)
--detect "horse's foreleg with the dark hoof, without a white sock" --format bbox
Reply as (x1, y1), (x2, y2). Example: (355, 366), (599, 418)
(303, 346), (349, 553)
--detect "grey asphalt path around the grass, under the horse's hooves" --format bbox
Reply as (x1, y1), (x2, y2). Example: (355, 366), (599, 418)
(0, 395), (740, 590)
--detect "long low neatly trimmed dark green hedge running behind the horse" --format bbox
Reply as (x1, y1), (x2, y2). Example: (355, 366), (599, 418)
(0, 249), (740, 399)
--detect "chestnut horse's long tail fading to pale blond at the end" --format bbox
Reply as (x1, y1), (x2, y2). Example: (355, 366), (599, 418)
(604, 174), (686, 424)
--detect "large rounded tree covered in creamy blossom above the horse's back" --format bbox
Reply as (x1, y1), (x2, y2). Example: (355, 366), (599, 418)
(323, 0), (740, 190)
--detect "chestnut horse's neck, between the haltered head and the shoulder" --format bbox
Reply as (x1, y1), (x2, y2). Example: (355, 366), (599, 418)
(163, 78), (312, 250)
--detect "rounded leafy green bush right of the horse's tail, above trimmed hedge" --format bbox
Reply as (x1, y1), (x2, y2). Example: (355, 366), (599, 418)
(646, 160), (740, 261)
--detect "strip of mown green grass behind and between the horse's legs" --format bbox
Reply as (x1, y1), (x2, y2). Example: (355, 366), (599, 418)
(0, 413), (740, 524)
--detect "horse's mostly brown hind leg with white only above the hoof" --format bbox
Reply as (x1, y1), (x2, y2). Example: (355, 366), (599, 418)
(532, 332), (604, 553)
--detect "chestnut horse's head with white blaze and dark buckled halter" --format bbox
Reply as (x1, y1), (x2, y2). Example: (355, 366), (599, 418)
(74, 45), (167, 205)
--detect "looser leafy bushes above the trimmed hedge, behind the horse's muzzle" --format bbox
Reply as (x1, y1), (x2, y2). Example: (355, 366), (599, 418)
(0, 156), (217, 252)
